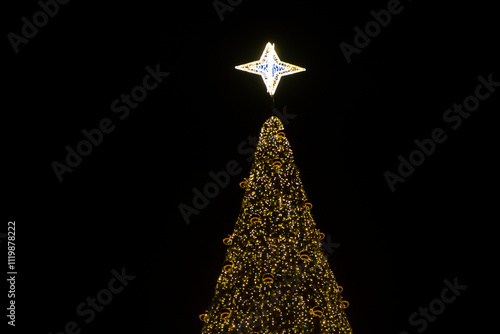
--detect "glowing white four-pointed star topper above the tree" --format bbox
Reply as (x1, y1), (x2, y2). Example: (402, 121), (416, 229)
(235, 43), (306, 96)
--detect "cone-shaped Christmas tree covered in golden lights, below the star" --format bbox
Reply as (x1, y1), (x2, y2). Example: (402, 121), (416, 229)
(200, 116), (352, 334)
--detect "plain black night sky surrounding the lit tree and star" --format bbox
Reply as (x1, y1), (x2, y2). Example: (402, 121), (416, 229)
(1, 0), (500, 334)
